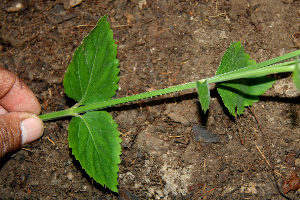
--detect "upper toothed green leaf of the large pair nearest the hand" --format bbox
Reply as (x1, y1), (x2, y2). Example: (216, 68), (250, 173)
(64, 16), (119, 105)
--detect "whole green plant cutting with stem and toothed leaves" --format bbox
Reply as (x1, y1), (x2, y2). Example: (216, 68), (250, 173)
(40, 16), (300, 192)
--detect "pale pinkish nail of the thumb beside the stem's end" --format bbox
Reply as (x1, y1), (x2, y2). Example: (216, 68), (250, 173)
(21, 115), (44, 145)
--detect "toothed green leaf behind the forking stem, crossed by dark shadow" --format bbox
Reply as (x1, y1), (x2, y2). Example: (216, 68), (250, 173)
(216, 42), (275, 116)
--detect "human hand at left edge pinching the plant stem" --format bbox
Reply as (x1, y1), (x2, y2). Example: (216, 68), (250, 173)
(0, 67), (44, 158)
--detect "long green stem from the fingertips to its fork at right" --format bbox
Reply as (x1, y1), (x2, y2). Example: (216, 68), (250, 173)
(40, 57), (300, 121)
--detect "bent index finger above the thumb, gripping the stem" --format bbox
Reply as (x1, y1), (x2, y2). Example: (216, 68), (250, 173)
(0, 67), (41, 114)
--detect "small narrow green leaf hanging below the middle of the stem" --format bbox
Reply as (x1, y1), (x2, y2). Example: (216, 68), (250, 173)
(196, 79), (210, 113)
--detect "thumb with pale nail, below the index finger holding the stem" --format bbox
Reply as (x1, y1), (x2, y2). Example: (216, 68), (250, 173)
(0, 112), (44, 158)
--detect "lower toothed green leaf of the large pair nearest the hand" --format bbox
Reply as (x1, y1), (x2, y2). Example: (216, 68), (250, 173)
(68, 111), (121, 192)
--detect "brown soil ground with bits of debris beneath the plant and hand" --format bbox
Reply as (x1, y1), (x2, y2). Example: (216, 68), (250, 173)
(0, 0), (300, 199)
